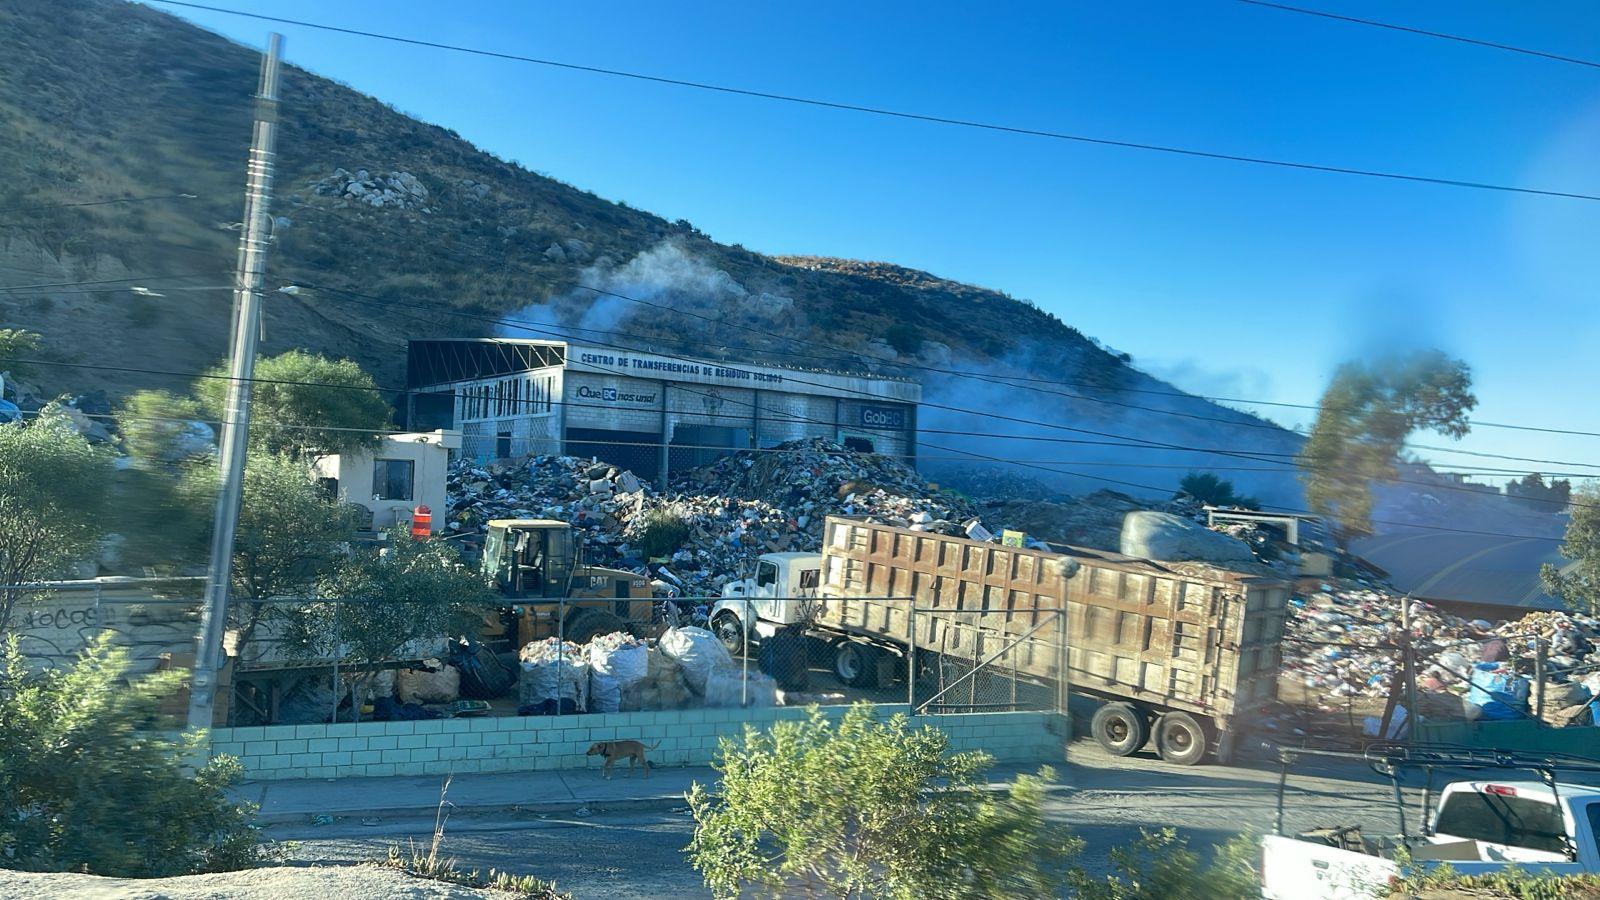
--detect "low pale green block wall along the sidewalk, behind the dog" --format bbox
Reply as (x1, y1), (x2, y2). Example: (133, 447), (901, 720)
(211, 705), (1070, 780)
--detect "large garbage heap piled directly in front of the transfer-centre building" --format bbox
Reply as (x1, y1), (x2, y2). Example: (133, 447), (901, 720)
(445, 440), (978, 596)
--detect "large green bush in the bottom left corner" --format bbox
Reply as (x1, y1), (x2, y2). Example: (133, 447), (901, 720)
(0, 636), (261, 878)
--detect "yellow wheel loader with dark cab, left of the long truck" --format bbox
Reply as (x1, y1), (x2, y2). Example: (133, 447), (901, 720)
(480, 519), (654, 649)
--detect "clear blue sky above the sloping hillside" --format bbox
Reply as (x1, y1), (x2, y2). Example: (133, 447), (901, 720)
(152, 0), (1600, 471)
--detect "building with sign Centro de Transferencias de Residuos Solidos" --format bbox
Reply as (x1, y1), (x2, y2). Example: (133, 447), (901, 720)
(406, 338), (922, 479)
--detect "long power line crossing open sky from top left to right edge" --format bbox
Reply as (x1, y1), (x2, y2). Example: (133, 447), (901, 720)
(154, 0), (1600, 200)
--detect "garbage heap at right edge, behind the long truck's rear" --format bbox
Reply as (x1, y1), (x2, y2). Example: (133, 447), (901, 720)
(1283, 580), (1600, 716)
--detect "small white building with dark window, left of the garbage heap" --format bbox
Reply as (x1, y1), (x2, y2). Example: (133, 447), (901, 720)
(315, 429), (461, 532)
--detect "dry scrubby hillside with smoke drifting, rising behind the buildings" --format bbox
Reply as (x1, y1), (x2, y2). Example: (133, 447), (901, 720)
(0, 0), (1324, 501)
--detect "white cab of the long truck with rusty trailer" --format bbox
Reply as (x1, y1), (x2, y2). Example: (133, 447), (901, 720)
(710, 552), (822, 653)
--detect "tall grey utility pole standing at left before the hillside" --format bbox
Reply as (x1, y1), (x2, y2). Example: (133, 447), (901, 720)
(189, 34), (283, 730)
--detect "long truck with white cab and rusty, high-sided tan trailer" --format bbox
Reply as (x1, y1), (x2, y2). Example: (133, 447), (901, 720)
(710, 517), (1290, 765)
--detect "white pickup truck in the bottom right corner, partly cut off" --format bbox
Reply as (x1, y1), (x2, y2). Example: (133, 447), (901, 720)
(1261, 781), (1600, 900)
